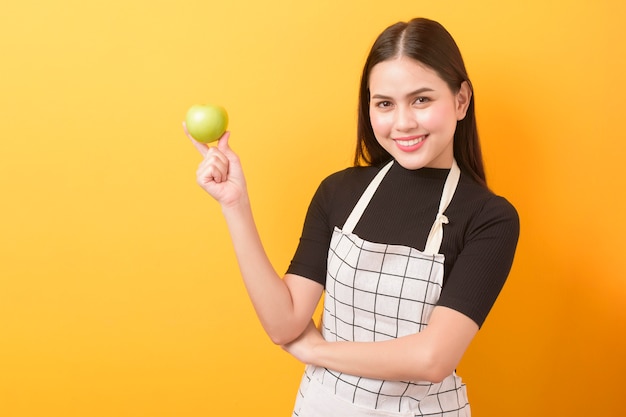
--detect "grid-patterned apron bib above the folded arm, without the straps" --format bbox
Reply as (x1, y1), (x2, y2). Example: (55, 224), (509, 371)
(323, 228), (444, 342)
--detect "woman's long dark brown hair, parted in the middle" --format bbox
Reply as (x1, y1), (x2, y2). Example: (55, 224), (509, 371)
(354, 18), (487, 186)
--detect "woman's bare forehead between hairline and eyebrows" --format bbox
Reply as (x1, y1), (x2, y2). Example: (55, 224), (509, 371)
(369, 56), (447, 90)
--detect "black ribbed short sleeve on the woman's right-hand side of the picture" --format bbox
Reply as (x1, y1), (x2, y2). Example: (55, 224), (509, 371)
(438, 196), (520, 327)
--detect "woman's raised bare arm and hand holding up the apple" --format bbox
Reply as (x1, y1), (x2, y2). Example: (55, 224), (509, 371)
(185, 124), (323, 344)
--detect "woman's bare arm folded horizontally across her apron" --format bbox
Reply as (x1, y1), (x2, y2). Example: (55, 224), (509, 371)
(283, 306), (478, 382)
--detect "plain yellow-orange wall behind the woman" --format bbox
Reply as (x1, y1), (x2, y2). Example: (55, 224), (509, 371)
(0, 0), (626, 417)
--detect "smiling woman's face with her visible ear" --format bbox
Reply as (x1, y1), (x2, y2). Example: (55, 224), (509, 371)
(369, 57), (471, 169)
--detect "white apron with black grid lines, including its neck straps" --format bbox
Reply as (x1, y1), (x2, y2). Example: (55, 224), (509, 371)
(293, 161), (470, 417)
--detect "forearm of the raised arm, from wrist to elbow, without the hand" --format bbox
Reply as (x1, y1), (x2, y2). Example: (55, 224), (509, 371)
(223, 201), (310, 344)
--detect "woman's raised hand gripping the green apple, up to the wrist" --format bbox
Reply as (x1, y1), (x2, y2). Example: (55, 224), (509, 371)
(183, 122), (248, 207)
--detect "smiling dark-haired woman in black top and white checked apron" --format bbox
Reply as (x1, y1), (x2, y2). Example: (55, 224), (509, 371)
(184, 19), (519, 417)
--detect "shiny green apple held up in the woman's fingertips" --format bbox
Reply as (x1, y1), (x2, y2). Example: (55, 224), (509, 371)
(185, 104), (228, 143)
